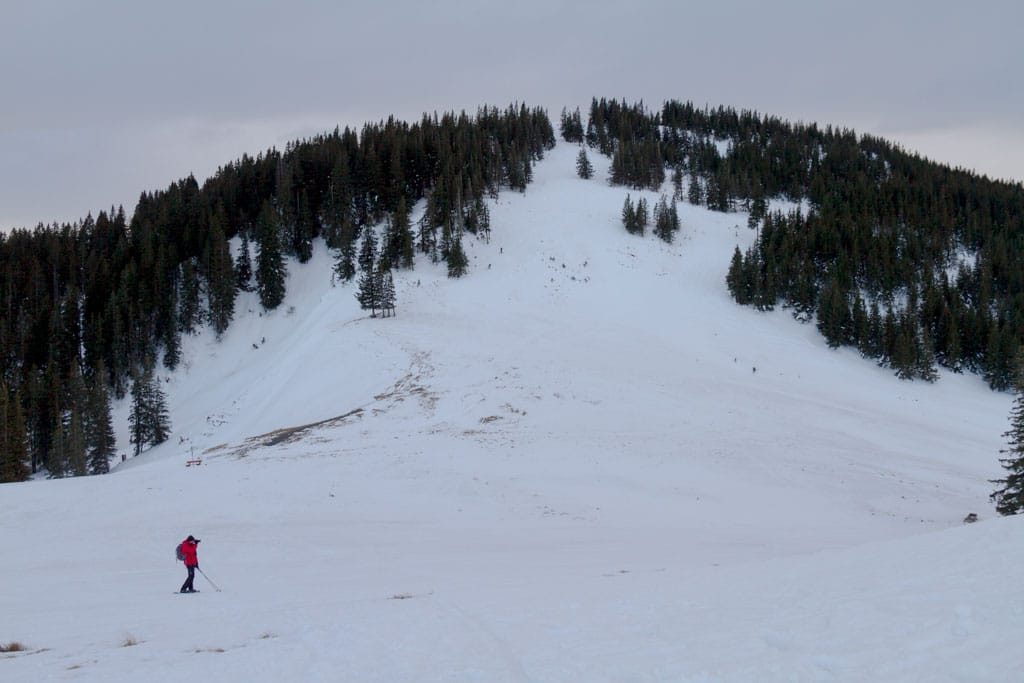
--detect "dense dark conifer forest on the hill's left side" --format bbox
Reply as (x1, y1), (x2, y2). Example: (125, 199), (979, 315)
(0, 104), (554, 481)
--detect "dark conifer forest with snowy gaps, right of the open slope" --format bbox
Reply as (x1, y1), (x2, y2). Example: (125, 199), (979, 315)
(581, 94), (1024, 390)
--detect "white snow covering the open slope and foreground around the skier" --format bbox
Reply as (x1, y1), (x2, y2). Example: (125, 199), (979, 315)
(0, 144), (1024, 682)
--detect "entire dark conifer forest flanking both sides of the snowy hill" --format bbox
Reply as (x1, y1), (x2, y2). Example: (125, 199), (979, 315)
(0, 98), (1024, 481)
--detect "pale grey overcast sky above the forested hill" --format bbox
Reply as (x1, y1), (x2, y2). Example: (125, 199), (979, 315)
(0, 0), (1024, 228)
